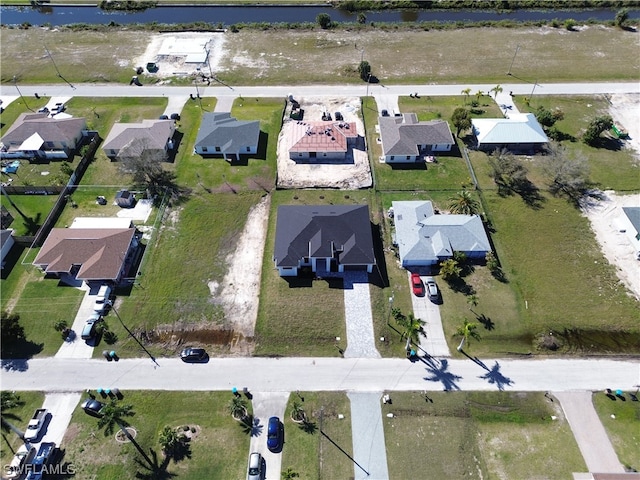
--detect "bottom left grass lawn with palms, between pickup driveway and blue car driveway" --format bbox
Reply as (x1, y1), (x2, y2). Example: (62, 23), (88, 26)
(62, 391), (250, 480)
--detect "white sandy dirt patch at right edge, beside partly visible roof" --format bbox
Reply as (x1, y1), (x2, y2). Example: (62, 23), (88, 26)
(583, 191), (640, 300)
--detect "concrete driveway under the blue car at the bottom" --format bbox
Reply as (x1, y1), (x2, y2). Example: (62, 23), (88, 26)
(247, 392), (289, 480)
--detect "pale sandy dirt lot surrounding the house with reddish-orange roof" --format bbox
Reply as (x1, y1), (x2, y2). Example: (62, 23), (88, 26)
(277, 97), (372, 190)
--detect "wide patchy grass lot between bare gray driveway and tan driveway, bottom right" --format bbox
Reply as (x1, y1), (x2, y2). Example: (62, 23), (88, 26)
(382, 392), (586, 479)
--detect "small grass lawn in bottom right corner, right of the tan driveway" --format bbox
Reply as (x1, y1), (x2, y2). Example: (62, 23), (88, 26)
(593, 391), (640, 471)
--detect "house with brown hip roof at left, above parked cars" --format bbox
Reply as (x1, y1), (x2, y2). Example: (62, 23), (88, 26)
(33, 228), (140, 283)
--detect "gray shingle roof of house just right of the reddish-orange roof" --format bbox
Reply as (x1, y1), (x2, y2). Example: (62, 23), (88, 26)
(378, 113), (454, 155)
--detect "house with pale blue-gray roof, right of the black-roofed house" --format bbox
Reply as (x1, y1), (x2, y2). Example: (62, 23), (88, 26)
(392, 200), (491, 268)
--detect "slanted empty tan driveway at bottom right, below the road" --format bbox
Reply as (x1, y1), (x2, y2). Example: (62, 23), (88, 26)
(553, 391), (625, 473)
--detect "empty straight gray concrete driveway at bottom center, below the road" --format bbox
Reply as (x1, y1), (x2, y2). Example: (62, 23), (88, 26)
(347, 392), (389, 480)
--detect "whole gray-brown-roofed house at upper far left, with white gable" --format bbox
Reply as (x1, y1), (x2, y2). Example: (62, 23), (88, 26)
(0, 113), (87, 160)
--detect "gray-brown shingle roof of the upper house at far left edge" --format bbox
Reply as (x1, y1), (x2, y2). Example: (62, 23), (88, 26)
(0, 113), (87, 146)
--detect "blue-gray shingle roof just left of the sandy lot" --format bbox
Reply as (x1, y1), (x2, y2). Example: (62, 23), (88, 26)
(195, 112), (260, 153)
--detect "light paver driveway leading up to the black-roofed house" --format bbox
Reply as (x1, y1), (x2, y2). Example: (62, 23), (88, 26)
(344, 272), (380, 358)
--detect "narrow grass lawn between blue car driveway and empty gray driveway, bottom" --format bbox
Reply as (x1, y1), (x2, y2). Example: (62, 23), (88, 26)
(281, 392), (353, 478)
